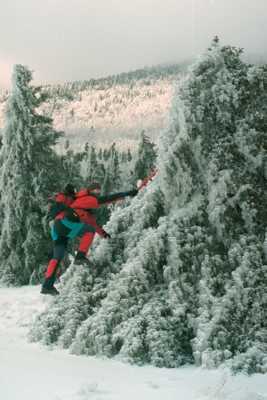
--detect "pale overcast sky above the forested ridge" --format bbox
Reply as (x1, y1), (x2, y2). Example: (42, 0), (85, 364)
(0, 0), (267, 86)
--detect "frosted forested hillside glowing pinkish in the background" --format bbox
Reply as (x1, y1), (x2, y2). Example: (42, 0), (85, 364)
(0, 64), (186, 150)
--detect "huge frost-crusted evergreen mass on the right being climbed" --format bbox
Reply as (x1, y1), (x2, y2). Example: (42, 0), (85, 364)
(31, 40), (267, 372)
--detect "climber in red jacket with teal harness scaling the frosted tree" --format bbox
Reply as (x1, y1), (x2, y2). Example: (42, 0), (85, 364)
(41, 183), (138, 295)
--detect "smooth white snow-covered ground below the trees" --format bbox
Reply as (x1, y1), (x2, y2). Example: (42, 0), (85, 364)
(0, 287), (267, 400)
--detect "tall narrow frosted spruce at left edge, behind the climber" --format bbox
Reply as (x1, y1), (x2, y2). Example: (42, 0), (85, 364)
(0, 65), (60, 285)
